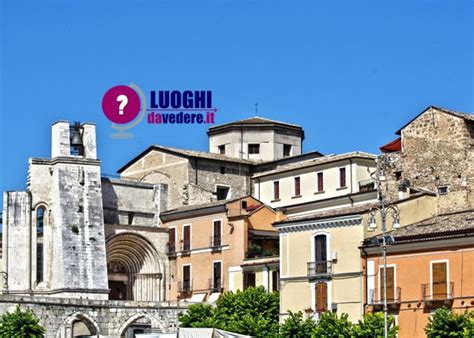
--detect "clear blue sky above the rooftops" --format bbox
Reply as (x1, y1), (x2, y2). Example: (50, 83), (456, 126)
(0, 0), (474, 206)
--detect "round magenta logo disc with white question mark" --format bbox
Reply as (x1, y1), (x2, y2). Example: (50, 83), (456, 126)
(102, 86), (140, 124)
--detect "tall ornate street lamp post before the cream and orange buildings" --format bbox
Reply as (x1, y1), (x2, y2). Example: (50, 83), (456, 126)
(367, 156), (400, 338)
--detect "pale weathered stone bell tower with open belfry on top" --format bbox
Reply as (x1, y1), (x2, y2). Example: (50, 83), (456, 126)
(3, 121), (108, 299)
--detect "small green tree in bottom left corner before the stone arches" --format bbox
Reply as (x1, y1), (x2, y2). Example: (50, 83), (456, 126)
(0, 306), (46, 338)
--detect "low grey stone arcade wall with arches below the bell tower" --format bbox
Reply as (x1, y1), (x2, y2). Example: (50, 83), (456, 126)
(0, 295), (186, 338)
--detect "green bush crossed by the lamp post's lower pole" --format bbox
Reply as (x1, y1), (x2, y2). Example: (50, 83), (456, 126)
(352, 312), (399, 338)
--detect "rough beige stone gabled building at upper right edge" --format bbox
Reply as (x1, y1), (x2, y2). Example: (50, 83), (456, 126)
(385, 108), (474, 213)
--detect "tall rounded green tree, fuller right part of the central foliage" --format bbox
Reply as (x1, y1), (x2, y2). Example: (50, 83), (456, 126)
(214, 286), (279, 337)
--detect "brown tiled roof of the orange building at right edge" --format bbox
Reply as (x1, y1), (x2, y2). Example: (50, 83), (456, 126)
(364, 210), (474, 247)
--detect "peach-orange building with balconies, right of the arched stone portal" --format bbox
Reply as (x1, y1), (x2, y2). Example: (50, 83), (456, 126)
(160, 197), (278, 303)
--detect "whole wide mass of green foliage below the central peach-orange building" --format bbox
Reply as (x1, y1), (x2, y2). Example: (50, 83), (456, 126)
(179, 287), (279, 337)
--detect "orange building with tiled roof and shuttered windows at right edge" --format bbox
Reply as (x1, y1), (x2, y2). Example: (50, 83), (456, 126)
(361, 210), (474, 337)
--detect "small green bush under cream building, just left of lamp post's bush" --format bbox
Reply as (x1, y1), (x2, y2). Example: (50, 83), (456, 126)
(313, 312), (352, 337)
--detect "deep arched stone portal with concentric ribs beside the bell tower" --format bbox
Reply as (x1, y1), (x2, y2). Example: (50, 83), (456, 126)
(106, 233), (164, 301)
